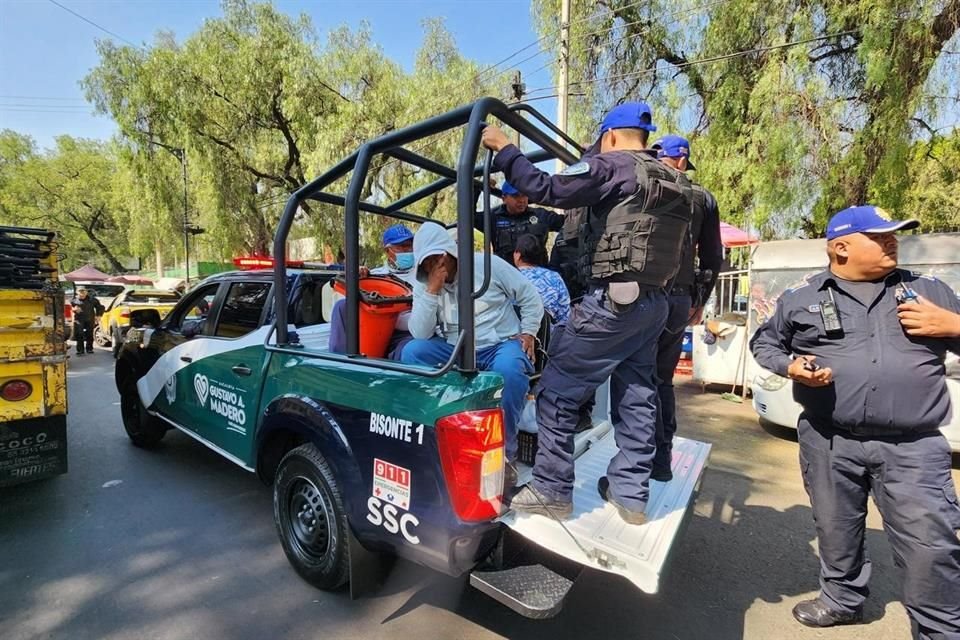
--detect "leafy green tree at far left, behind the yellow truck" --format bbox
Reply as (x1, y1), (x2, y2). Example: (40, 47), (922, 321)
(0, 131), (125, 272)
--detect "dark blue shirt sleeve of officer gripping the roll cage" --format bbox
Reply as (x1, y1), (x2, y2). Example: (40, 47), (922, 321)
(493, 144), (656, 209)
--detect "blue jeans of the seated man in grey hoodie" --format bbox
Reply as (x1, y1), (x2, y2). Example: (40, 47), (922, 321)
(401, 337), (533, 461)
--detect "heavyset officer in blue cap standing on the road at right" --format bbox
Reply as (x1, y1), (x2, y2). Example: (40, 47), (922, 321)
(750, 206), (960, 639)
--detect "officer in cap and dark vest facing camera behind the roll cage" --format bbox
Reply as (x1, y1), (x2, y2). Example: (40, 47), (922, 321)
(473, 181), (564, 264)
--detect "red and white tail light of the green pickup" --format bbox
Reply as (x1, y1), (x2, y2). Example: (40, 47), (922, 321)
(437, 409), (504, 522)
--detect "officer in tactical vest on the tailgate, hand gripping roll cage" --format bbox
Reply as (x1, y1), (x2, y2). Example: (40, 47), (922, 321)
(483, 102), (693, 524)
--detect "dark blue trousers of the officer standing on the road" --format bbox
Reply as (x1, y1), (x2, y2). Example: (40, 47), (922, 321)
(797, 415), (960, 640)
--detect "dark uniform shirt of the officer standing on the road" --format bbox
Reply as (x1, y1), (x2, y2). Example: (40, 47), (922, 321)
(750, 269), (960, 432)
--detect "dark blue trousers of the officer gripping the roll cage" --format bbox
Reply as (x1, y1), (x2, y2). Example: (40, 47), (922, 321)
(533, 288), (667, 511)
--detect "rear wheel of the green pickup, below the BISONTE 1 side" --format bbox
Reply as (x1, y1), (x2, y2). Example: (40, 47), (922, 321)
(273, 444), (350, 590)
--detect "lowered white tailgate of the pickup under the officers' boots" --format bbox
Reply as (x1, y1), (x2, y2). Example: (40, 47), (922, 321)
(501, 430), (710, 593)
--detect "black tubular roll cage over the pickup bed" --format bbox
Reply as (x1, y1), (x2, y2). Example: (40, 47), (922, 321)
(267, 97), (583, 377)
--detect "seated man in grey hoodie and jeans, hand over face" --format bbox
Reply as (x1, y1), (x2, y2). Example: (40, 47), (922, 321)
(401, 223), (543, 462)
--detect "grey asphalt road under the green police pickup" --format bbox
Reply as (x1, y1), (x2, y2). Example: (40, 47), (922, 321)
(0, 350), (960, 640)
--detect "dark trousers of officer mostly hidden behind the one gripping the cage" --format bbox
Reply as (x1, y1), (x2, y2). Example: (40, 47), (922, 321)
(653, 294), (692, 469)
